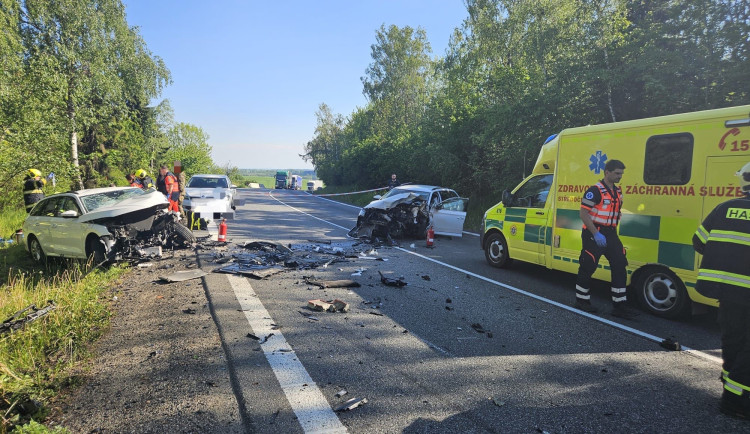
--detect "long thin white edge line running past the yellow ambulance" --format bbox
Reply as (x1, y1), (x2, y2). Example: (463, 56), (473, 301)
(269, 193), (723, 365)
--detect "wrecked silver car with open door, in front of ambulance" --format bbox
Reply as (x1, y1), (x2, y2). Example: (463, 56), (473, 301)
(349, 185), (469, 240)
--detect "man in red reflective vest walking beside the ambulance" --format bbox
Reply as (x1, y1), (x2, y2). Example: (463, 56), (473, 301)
(574, 160), (636, 319)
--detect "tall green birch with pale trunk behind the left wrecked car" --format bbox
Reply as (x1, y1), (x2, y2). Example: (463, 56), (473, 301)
(15, 0), (170, 188)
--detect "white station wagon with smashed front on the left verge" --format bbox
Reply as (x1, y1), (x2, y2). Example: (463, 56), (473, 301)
(23, 187), (196, 263)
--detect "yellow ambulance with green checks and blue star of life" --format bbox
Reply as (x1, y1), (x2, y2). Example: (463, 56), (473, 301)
(480, 105), (750, 318)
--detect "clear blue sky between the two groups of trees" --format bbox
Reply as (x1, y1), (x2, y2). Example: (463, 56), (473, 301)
(123, 0), (467, 169)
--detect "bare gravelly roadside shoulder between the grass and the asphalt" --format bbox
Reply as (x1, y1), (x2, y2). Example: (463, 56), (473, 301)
(46, 249), (246, 433)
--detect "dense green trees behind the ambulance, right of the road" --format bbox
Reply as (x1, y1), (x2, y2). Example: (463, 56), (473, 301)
(301, 0), (750, 197)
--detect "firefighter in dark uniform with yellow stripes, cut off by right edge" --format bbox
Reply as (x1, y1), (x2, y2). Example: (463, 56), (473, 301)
(693, 163), (750, 419)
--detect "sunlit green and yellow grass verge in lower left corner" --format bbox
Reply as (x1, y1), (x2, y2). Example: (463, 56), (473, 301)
(0, 206), (126, 433)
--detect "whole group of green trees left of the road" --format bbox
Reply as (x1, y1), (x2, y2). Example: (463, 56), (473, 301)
(0, 0), (222, 207)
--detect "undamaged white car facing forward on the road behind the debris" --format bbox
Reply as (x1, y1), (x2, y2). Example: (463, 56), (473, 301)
(182, 174), (242, 221)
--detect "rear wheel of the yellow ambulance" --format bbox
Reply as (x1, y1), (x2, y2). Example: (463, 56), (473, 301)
(634, 266), (690, 319)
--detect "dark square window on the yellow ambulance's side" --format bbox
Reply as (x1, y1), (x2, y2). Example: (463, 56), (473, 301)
(644, 133), (693, 185)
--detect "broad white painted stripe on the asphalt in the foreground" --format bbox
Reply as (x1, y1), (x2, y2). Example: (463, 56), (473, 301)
(227, 276), (348, 433)
